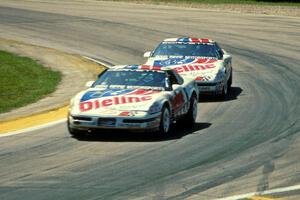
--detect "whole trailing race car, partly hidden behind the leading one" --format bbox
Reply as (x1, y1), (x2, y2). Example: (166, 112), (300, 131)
(144, 38), (232, 96)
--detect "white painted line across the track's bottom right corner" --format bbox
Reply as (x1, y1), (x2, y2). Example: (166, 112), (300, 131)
(217, 185), (300, 200)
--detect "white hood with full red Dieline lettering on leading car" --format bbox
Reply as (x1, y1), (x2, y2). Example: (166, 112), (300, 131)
(70, 88), (165, 116)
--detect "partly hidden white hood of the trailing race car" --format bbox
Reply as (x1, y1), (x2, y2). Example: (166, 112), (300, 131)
(146, 56), (223, 81)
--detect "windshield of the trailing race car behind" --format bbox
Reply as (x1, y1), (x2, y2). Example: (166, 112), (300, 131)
(152, 43), (217, 57)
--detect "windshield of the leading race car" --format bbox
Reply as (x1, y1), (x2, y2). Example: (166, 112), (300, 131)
(93, 70), (166, 89)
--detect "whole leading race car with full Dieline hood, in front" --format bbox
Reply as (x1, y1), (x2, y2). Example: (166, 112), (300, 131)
(68, 65), (198, 136)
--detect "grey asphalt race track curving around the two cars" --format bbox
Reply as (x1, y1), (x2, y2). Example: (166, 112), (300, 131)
(0, 0), (300, 200)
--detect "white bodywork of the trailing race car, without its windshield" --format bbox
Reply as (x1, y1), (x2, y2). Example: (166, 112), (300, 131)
(144, 38), (232, 95)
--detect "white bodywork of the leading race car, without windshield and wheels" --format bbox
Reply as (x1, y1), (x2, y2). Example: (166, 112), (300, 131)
(68, 66), (198, 134)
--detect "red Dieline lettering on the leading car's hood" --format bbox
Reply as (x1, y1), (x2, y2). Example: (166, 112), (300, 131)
(79, 96), (152, 112)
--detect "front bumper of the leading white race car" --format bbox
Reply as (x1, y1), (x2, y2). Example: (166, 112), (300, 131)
(68, 113), (161, 130)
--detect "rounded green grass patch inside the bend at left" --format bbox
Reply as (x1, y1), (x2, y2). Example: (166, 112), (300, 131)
(0, 51), (61, 113)
